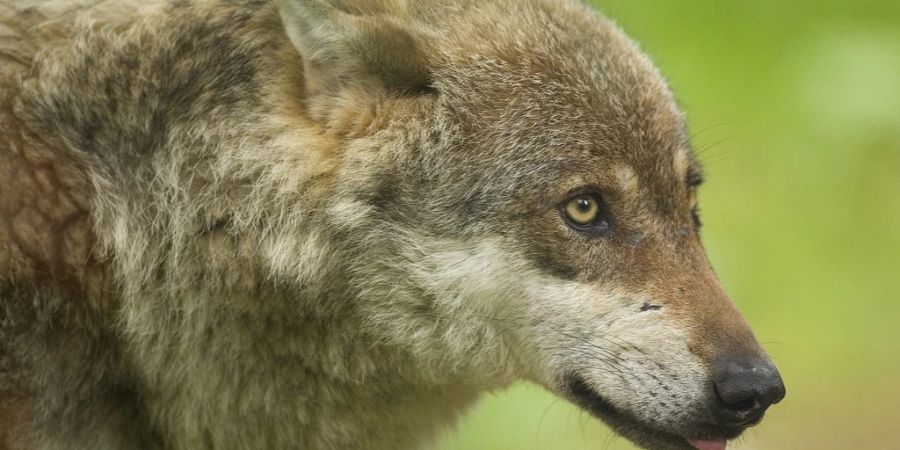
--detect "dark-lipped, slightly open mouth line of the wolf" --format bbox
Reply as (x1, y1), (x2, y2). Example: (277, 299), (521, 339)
(565, 375), (743, 450)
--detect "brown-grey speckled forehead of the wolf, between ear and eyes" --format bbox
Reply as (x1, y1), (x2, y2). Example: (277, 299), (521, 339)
(398, 0), (699, 200)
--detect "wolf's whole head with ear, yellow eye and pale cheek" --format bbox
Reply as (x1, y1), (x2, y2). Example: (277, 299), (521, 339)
(279, 0), (784, 449)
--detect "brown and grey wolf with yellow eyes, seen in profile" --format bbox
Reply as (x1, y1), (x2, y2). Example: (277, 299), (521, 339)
(0, 0), (785, 450)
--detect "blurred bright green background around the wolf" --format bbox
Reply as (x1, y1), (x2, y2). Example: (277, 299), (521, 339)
(438, 0), (900, 450)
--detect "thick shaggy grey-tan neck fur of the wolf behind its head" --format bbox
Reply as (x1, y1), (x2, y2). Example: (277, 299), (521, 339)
(12, 1), (506, 449)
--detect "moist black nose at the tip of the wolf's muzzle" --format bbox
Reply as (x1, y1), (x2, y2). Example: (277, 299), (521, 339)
(713, 358), (785, 426)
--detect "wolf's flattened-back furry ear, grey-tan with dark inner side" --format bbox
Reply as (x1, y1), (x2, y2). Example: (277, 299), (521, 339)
(277, 0), (433, 95)
